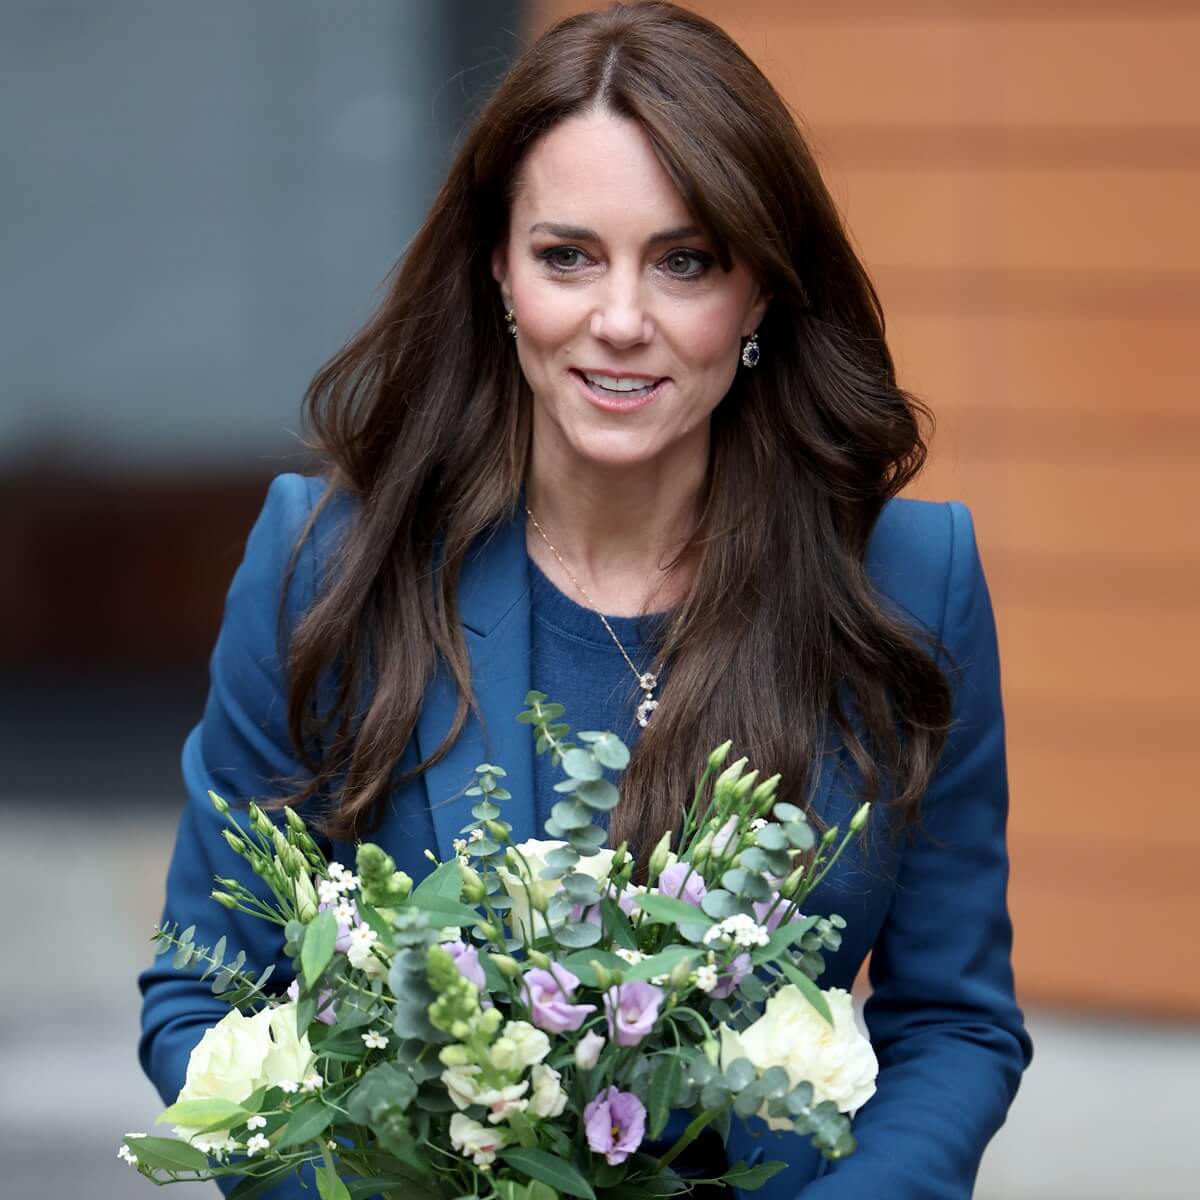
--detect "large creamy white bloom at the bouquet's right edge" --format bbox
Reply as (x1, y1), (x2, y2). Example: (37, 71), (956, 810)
(721, 984), (880, 1129)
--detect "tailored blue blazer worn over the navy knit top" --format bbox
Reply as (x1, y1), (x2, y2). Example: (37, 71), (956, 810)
(139, 475), (1032, 1200)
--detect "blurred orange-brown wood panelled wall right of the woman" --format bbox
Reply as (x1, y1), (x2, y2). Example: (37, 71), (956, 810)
(533, 0), (1200, 1016)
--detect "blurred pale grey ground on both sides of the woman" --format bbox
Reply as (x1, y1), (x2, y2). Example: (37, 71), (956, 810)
(0, 805), (1200, 1200)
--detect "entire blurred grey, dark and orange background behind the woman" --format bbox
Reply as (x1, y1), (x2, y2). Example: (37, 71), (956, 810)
(0, 0), (1200, 1200)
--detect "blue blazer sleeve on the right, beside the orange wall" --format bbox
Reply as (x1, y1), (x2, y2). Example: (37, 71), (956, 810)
(803, 502), (1032, 1200)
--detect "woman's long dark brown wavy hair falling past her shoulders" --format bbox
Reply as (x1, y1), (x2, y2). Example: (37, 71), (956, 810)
(276, 2), (950, 846)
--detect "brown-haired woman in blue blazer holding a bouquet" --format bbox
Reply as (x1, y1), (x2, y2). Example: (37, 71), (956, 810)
(140, 4), (1031, 1200)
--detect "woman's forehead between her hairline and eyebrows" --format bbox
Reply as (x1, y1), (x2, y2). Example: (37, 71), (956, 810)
(512, 112), (692, 236)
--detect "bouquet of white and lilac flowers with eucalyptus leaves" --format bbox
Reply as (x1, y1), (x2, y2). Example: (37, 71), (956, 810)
(120, 691), (877, 1200)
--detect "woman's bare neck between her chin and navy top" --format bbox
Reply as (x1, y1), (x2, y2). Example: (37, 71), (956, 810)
(526, 428), (708, 616)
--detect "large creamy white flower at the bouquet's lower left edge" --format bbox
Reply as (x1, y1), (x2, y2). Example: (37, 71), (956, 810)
(175, 1002), (314, 1153)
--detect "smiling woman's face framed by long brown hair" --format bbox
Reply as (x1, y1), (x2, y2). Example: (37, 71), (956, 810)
(492, 112), (767, 467)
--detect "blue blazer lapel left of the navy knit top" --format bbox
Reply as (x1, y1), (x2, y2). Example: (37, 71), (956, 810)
(416, 520), (534, 862)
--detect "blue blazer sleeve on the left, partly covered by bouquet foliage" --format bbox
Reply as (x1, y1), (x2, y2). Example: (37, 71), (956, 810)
(138, 475), (328, 1198)
